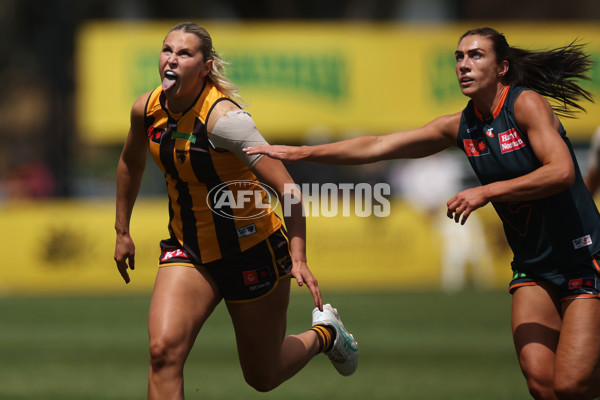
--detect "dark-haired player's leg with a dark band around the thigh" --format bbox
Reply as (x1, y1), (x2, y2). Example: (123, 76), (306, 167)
(512, 285), (561, 400)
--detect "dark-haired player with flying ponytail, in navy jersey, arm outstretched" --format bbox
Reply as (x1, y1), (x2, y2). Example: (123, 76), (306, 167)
(246, 28), (600, 400)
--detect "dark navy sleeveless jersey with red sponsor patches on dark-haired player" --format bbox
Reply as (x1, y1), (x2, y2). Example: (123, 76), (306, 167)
(458, 86), (600, 273)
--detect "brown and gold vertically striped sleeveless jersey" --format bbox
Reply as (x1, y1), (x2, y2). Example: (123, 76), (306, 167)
(145, 82), (281, 263)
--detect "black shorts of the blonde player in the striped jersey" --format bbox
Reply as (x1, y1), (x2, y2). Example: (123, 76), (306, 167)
(159, 229), (292, 302)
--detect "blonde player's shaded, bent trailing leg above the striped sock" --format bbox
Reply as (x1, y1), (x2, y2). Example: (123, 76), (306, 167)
(227, 279), (319, 392)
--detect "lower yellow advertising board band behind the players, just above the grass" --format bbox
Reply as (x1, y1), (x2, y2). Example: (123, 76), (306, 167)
(0, 198), (512, 297)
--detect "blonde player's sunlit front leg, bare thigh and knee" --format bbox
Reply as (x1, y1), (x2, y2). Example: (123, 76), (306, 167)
(148, 265), (221, 400)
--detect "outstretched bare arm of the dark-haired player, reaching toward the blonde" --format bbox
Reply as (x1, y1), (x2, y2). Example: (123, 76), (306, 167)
(244, 113), (460, 165)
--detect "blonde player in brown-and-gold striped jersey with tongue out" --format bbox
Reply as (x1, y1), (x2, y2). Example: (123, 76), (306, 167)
(114, 23), (358, 400)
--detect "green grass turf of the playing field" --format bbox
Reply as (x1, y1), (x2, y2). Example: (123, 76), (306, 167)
(0, 291), (530, 400)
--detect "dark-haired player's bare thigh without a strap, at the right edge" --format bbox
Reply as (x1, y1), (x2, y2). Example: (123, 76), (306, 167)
(554, 299), (600, 400)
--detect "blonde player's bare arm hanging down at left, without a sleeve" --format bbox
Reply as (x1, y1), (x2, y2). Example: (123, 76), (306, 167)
(114, 95), (148, 283)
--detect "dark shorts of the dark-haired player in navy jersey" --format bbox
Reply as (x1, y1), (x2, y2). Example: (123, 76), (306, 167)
(509, 255), (600, 301)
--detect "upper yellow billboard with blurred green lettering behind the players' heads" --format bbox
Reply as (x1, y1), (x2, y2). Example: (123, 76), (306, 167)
(77, 21), (600, 143)
